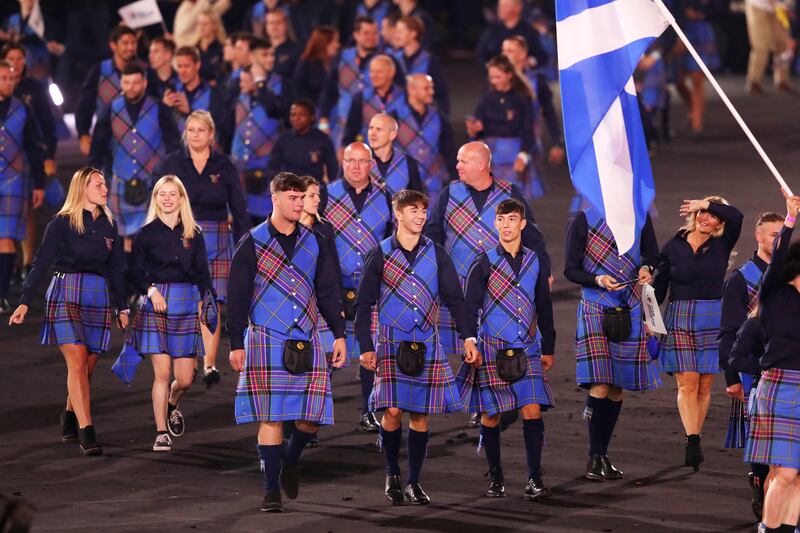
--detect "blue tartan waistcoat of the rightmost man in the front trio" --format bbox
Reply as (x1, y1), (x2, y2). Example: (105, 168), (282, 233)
(481, 247), (539, 344)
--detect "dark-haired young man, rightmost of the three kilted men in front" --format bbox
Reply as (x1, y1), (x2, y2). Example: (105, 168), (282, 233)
(456, 198), (556, 500)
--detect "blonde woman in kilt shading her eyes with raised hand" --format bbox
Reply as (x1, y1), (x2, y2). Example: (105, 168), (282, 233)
(654, 196), (743, 470)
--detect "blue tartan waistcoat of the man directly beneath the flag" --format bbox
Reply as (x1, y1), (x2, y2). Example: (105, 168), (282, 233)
(581, 207), (642, 307)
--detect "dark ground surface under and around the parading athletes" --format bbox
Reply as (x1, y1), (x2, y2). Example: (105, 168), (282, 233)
(0, 60), (800, 533)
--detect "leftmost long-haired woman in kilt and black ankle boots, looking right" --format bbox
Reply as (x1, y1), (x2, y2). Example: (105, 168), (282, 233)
(9, 167), (128, 455)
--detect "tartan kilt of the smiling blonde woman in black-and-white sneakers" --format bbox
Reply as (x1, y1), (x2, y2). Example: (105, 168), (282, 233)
(130, 283), (205, 359)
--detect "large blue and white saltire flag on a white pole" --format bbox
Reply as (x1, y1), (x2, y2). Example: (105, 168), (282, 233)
(556, 0), (669, 255)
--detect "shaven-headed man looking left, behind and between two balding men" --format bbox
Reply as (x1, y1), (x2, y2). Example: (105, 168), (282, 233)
(367, 113), (423, 196)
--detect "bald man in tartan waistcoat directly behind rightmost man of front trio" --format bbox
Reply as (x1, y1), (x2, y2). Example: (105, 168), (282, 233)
(425, 142), (550, 368)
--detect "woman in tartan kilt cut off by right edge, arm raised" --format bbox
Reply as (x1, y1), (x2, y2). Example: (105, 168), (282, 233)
(744, 196), (800, 532)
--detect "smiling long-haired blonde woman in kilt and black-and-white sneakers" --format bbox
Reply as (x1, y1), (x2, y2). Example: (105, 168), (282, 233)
(128, 176), (214, 452)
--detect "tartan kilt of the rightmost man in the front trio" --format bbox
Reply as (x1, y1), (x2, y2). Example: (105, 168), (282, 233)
(456, 335), (555, 416)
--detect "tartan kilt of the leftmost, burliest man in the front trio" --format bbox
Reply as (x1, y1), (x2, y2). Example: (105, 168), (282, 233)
(234, 324), (333, 425)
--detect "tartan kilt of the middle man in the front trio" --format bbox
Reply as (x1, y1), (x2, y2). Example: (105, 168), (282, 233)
(369, 324), (464, 414)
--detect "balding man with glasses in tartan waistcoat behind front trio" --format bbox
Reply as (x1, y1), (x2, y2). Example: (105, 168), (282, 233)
(325, 142), (392, 432)
